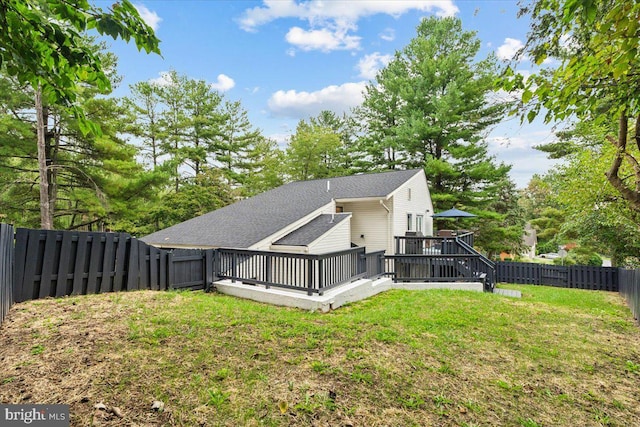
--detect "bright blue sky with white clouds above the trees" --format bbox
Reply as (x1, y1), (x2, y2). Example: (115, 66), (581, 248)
(96, 0), (553, 188)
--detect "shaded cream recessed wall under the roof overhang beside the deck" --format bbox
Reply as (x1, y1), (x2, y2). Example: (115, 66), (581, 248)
(337, 200), (393, 253)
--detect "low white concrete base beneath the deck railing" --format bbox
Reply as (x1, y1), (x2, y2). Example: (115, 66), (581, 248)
(214, 278), (483, 312)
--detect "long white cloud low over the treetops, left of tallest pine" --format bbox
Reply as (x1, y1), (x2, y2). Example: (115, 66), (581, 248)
(268, 82), (366, 119)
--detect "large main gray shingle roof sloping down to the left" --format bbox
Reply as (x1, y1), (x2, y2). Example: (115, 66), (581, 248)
(140, 169), (421, 248)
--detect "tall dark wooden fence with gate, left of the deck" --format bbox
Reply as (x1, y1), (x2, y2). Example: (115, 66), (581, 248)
(13, 228), (213, 302)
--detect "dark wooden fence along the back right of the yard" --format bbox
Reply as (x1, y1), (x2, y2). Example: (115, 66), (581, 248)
(496, 262), (620, 292)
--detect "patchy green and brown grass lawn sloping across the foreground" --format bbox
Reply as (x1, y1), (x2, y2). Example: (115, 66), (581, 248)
(0, 285), (640, 427)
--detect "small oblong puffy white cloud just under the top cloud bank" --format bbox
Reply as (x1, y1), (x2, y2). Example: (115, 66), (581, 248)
(285, 27), (360, 52)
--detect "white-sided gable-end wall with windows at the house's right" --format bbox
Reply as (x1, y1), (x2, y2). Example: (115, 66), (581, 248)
(389, 173), (433, 236)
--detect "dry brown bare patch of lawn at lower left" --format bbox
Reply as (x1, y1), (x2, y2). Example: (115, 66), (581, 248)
(0, 292), (169, 426)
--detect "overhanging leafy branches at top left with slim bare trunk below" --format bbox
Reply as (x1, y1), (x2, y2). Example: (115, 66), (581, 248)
(0, 0), (160, 229)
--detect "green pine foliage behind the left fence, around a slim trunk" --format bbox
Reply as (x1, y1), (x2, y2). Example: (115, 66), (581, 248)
(0, 64), (162, 231)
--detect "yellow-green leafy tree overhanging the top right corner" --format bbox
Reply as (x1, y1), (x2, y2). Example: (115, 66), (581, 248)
(510, 0), (640, 212)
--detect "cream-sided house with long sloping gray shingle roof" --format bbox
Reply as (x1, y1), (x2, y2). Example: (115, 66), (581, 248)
(141, 169), (433, 254)
